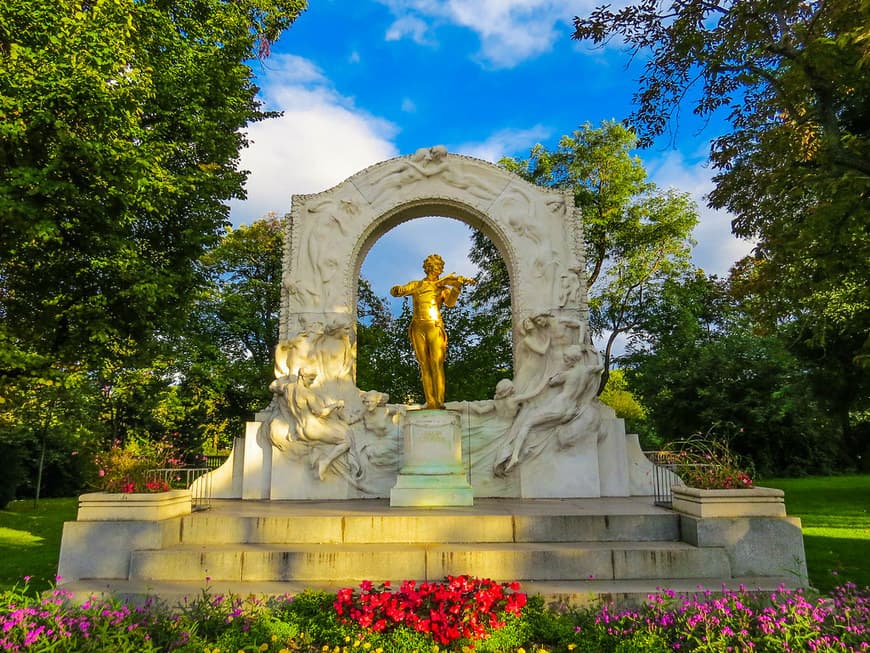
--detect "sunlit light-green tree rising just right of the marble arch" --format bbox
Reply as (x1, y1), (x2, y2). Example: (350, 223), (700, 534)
(502, 122), (698, 391)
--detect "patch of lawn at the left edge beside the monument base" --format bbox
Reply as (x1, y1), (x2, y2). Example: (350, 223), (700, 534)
(0, 498), (78, 591)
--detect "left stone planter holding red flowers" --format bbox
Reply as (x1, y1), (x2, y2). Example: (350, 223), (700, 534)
(76, 490), (192, 521)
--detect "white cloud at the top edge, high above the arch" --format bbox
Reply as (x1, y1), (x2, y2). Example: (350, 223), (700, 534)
(380, 0), (596, 68)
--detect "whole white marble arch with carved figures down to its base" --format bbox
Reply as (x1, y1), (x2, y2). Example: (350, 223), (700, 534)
(203, 146), (653, 499)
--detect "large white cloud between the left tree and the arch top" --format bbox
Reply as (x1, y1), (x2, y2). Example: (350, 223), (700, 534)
(230, 55), (398, 224)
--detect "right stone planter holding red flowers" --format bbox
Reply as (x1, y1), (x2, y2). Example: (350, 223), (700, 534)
(671, 485), (786, 519)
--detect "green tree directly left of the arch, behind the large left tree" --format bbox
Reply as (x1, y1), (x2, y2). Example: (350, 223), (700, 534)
(173, 215), (284, 449)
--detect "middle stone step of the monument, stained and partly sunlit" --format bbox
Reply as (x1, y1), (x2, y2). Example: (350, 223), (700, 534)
(130, 542), (730, 584)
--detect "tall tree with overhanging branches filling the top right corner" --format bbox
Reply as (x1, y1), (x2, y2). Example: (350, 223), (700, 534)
(574, 0), (870, 376)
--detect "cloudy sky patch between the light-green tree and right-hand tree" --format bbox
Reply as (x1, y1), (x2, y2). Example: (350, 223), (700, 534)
(645, 152), (753, 277)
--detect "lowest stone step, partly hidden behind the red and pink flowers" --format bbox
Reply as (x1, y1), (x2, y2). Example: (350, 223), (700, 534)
(61, 576), (799, 607)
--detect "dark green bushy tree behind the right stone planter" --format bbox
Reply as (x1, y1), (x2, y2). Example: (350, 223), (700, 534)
(623, 271), (843, 474)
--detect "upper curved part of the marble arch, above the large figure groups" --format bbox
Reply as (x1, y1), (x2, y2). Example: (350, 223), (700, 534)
(280, 146), (586, 362)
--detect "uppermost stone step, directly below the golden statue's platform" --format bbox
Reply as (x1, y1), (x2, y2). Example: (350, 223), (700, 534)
(179, 511), (680, 545)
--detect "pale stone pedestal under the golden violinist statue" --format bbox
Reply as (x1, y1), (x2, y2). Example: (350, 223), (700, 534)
(390, 410), (474, 507)
